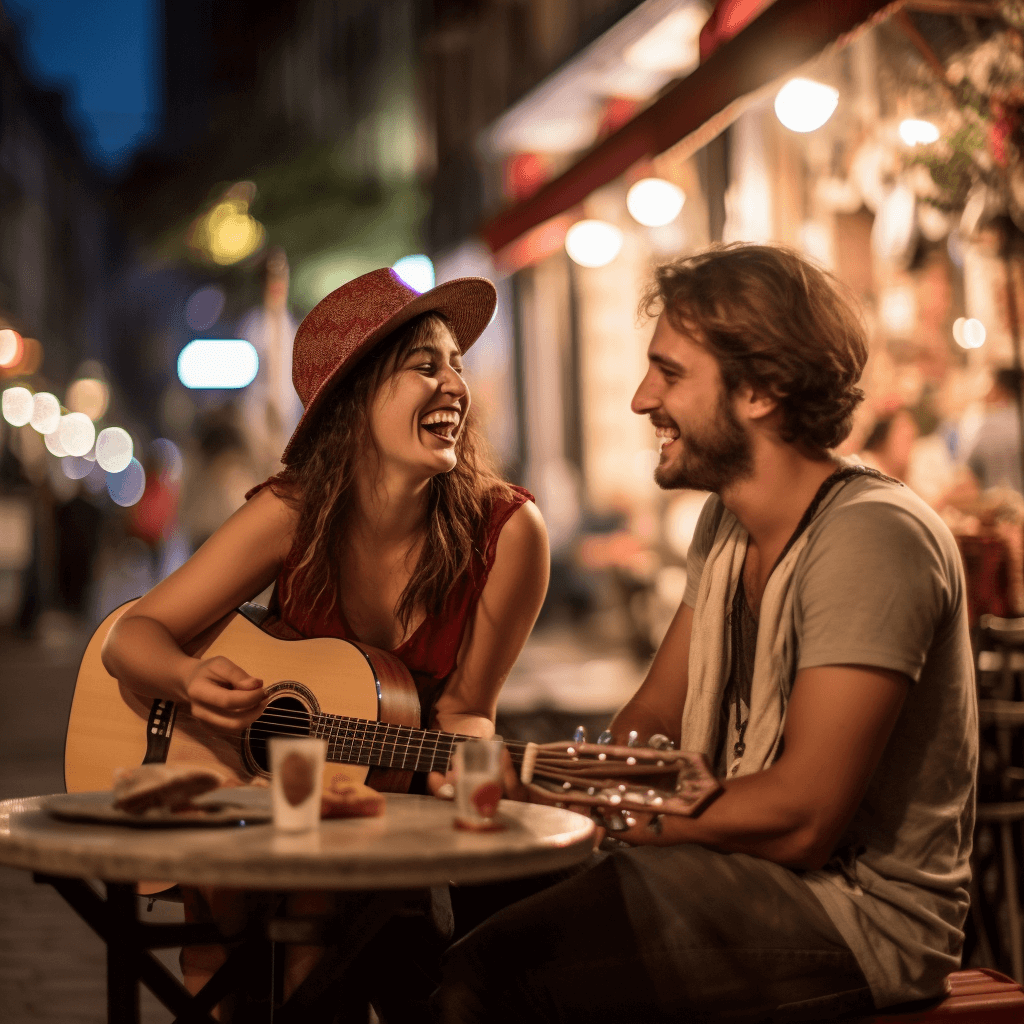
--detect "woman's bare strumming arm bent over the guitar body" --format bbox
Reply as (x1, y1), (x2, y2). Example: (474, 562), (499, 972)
(101, 487), (296, 732)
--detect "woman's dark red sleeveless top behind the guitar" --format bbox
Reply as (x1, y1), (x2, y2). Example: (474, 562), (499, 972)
(246, 477), (534, 709)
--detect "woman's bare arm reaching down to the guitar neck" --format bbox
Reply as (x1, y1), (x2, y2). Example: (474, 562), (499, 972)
(432, 502), (551, 782)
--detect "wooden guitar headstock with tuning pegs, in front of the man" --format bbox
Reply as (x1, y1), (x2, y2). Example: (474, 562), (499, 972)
(519, 742), (721, 816)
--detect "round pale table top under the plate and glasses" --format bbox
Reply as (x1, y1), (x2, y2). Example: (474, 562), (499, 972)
(0, 794), (594, 889)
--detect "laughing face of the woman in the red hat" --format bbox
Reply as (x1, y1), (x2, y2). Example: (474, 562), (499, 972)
(370, 326), (470, 479)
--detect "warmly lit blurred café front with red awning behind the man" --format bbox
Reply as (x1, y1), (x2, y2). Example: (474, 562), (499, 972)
(428, 0), (1024, 640)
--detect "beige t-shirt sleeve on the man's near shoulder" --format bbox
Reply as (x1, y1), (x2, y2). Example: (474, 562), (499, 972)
(796, 502), (951, 682)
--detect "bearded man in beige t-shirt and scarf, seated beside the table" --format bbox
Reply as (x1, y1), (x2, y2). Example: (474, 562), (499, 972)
(438, 245), (978, 1024)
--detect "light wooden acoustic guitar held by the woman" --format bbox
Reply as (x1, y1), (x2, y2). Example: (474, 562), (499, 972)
(65, 602), (719, 815)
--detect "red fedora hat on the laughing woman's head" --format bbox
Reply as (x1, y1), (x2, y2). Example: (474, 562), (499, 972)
(281, 268), (498, 464)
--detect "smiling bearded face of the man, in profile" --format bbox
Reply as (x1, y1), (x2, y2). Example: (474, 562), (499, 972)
(632, 315), (754, 494)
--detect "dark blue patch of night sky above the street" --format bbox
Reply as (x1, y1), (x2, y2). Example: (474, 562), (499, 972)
(0, 0), (161, 171)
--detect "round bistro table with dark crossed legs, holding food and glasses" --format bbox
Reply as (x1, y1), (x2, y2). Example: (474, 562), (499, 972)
(0, 794), (594, 1024)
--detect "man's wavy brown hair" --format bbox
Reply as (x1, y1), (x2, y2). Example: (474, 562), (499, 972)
(640, 243), (867, 452)
